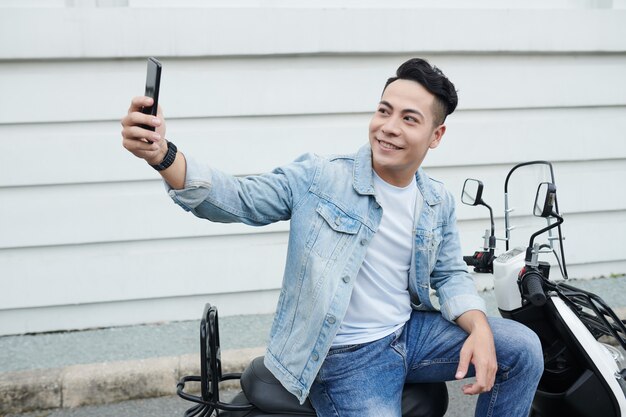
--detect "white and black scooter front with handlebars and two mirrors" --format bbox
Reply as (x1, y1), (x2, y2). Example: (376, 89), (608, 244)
(461, 161), (626, 417)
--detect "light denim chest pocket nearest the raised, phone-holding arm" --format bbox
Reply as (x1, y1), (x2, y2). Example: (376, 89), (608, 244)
(306, 200), (361, 259)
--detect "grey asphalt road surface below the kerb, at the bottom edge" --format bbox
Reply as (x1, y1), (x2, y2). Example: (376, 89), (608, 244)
(0, 382), (477, 417)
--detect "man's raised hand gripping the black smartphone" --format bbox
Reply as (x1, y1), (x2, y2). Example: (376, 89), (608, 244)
(122, 97), (167, 165)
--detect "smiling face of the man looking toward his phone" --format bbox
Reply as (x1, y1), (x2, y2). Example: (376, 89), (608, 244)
(369, 80), (446, 187)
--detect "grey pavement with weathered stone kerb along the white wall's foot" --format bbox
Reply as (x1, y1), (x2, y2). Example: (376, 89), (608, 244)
(0, 276), (626, 417)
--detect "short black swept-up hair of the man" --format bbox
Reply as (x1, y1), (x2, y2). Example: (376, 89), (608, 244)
(383, 58), (459, 125)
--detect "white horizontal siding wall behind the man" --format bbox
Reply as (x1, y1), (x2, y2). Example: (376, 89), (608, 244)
(0, 0), (626, 334)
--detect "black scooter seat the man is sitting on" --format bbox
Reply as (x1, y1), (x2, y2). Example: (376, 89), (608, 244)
(236, 356), (448, 417)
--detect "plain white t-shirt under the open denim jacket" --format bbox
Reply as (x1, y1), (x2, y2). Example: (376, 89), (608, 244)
(333, 172), (422, 346)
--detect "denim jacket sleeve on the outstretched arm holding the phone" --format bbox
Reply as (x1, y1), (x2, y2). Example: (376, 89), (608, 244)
(166, 154), (319, 226)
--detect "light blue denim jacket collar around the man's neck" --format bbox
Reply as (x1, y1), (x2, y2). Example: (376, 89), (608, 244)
(352, 145), (442, 206)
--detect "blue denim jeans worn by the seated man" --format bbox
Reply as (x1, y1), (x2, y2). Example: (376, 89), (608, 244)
(309, 311), (543, 417)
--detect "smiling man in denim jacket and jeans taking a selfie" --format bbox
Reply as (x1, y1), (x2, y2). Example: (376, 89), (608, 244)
(122, 59), (543, 417)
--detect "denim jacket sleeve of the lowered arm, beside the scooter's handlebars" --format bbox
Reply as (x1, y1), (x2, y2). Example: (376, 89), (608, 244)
(430, 191), (486, 321)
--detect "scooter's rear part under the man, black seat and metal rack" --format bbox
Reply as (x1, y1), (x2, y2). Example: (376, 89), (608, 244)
(176, 304), (448, 417)
